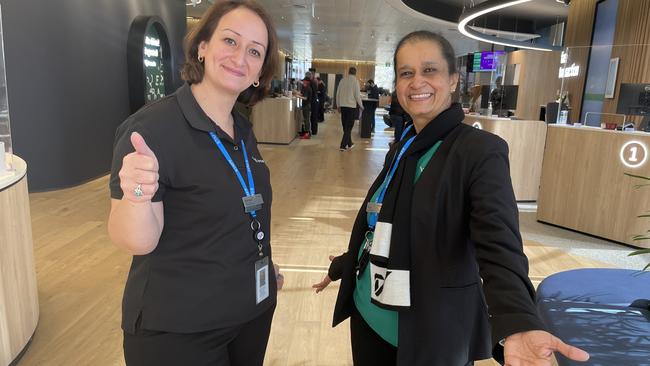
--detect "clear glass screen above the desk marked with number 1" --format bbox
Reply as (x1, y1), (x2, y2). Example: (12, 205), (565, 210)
(547, 42), (650, 132)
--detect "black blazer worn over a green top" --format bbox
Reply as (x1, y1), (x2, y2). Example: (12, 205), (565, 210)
(329, 123), (544, 366)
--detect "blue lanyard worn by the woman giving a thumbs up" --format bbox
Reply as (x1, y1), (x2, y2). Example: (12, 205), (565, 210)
(210, 132), (264, 257)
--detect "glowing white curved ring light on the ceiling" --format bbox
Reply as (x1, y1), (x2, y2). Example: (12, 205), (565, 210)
(458, 0), (562, 51)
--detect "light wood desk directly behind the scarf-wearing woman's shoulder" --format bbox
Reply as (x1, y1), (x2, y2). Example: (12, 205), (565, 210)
(463, 114), (546, 201)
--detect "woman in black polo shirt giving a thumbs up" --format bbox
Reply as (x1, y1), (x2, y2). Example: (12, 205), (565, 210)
(108, 1), (278, 366)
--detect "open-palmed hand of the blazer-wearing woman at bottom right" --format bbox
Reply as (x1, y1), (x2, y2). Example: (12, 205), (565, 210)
(504, 330), (589, 366)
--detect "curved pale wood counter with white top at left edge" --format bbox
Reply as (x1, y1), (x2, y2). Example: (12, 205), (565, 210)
(0, 155), (39, 366)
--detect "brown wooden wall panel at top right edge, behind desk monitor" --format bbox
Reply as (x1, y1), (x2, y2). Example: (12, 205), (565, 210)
(603, 0), (650, 126)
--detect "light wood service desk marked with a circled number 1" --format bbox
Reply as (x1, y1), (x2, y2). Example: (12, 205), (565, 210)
(537, 125), (650, 248)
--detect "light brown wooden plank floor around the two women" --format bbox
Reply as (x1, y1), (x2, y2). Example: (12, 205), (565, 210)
(20, 114), (603, 366)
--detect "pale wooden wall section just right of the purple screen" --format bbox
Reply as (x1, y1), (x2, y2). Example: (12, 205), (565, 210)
(508, 50), (560, 121)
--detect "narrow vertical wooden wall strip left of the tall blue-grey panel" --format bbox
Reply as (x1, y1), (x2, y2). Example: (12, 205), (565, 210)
(556, 0), (596, 121)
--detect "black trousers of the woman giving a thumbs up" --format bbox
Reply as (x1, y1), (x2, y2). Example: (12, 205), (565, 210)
(124, 307), (275, 366)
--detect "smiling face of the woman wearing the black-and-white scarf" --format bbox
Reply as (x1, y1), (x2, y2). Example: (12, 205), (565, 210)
(395, 40), (458, 131)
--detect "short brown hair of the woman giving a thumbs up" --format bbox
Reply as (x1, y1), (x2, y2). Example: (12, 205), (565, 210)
(181, 0), (279, 105)
